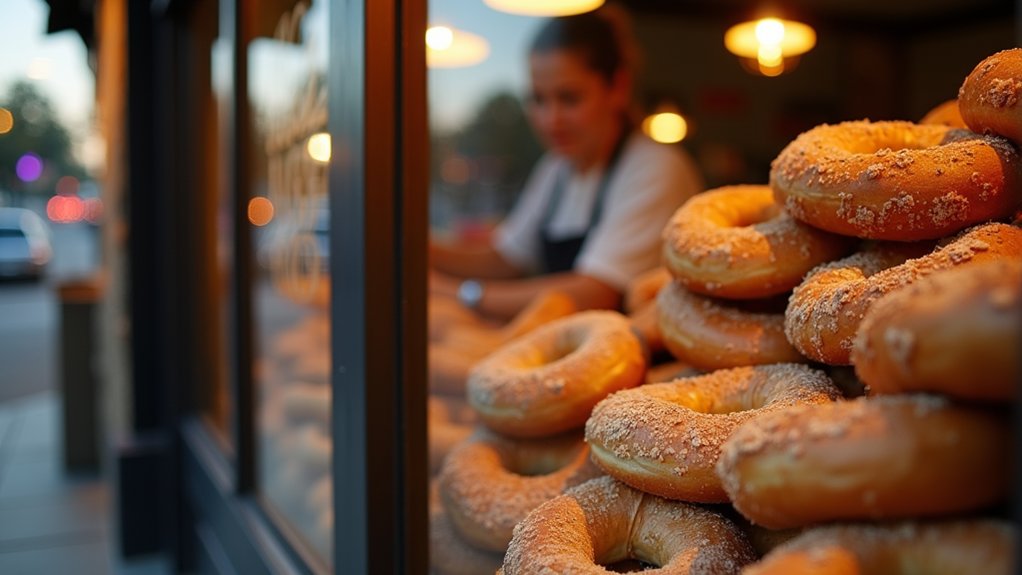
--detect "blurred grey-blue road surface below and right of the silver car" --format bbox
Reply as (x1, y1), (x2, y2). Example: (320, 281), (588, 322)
(0, 218), (99, 401)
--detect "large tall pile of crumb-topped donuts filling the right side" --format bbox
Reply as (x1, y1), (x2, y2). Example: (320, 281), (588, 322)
(492, 49), (1022, 575)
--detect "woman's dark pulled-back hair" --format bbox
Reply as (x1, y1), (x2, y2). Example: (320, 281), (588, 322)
(529, 5), (637, 83)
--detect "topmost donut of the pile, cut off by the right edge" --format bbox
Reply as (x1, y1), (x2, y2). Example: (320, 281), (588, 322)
(959, 48), (1022, 144)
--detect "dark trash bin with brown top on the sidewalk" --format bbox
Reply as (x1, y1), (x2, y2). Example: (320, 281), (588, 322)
(57, 277), (101, 472)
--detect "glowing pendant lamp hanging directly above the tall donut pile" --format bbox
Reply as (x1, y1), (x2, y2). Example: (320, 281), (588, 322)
(724, 18), (817, 76)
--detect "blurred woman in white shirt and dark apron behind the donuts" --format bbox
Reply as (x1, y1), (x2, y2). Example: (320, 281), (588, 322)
(429, 6), (703, 322)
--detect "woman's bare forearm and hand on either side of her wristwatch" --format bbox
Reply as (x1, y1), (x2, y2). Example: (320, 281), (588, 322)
(429, 272), (621, 321)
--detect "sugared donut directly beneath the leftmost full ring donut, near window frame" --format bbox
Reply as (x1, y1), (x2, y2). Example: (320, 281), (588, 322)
(437, 430), (602, 552)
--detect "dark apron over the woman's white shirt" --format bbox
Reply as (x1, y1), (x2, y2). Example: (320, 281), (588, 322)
(540, 130), (631, 274)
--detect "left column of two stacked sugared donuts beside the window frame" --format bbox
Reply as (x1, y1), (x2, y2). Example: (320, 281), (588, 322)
(430, 312), (647, 575)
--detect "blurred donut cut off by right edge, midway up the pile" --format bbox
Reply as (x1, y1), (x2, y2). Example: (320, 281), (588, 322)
(851, 259), (1022, 401)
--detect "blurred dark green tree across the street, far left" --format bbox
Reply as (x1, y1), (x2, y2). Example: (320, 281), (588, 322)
(0, 82), (87, 204)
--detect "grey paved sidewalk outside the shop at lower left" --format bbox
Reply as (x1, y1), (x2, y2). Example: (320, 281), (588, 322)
(0, 391), (170, 575)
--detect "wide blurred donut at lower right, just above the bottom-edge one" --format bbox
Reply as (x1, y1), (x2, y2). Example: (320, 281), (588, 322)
(716, 395), (1012, 529)
